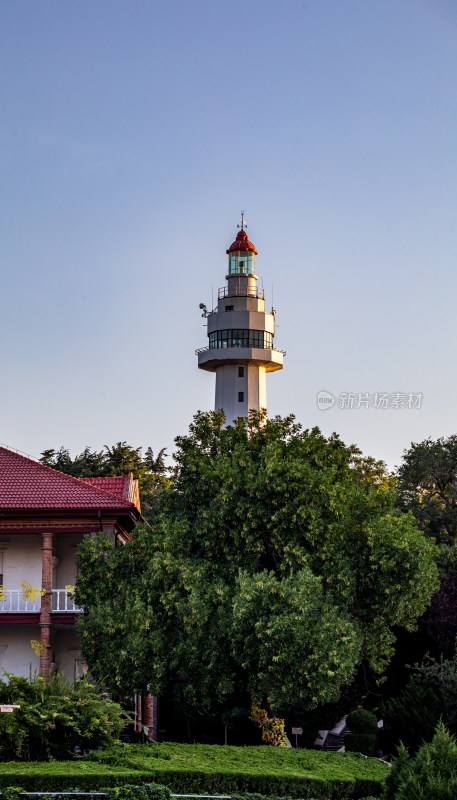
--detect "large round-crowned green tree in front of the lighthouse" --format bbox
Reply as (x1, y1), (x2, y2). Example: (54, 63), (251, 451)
(76, 413), (437, 709)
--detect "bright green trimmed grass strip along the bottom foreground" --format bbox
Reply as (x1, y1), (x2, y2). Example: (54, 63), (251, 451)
(0, 743), (389, 798)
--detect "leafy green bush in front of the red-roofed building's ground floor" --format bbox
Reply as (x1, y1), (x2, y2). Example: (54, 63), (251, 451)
(0, 673), (127, 761)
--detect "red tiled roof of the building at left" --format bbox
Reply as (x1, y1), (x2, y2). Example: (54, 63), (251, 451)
(0, 447), (136, 511)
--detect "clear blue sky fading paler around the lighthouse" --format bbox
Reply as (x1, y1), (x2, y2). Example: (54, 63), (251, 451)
(0, 0), (457, 472)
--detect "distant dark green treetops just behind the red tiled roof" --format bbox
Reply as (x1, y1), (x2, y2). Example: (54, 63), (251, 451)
(40, 442), (169, 522)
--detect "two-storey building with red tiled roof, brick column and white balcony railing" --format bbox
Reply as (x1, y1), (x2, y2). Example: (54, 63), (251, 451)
(0, 447), (141, 680)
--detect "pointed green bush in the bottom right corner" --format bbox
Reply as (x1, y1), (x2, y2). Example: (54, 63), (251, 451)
(382, 722), (457, 800)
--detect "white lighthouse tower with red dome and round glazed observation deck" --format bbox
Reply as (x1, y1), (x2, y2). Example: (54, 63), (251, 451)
(196, 213), (285, 425)
